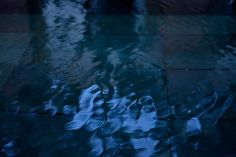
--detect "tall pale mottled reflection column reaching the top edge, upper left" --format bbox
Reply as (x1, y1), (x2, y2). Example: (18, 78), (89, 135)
(43, 0), (86, 81)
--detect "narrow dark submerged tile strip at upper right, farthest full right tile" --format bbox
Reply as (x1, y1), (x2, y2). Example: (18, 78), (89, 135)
(158, 15), (236, 36)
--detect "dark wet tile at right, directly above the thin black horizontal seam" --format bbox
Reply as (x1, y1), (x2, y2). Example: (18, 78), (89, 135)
(162, 34), (236, 69)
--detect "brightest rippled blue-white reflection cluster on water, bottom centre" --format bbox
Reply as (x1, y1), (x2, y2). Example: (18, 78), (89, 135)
(61, 82), (166, 156)
